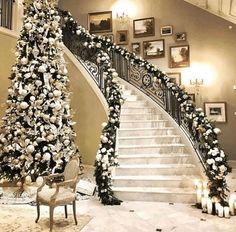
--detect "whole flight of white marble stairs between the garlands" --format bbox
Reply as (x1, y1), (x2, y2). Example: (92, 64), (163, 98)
(112, 81), (201, 203)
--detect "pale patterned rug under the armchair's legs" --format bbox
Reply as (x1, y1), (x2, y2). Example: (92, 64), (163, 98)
(0, 205), (92, 232)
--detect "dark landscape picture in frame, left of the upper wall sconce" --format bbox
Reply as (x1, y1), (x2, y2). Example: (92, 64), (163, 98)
(88, 11), (112, 33)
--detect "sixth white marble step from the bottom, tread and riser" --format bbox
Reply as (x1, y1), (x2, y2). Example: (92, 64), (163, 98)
(118, 135), (180, 146)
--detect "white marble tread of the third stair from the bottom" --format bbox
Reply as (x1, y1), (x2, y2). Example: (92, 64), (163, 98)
(117, 164), (195, 169)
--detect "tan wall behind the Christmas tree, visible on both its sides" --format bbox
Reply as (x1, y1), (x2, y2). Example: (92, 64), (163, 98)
(0, 31), (107, 165)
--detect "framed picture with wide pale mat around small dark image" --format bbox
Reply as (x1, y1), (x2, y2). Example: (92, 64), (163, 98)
(204, 102), (227, 122)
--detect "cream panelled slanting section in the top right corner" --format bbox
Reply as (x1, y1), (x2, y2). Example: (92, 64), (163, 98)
(184, 0), (236, 24)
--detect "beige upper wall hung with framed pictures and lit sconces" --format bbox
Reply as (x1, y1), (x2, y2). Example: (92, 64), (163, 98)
(59, 0), (236, 159)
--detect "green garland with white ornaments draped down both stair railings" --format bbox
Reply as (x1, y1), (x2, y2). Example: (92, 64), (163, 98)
(59, 12), (231, 205)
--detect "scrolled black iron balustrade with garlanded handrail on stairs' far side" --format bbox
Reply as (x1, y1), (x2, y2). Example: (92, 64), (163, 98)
(58, 9), (230, 202)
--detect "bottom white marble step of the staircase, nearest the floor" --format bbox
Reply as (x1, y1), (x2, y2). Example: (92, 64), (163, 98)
(112, 187), (196, 203)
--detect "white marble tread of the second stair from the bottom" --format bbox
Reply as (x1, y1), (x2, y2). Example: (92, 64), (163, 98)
(112, 175), (199, 181)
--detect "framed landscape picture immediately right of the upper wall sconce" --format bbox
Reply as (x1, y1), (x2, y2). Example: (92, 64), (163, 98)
(133, 17), (155, 38)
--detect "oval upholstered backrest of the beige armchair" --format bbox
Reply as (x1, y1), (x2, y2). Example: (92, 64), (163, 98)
(64, 157), (80, 181)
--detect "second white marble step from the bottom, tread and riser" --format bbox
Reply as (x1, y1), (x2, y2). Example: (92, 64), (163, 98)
(112, 175), (196, 188)
